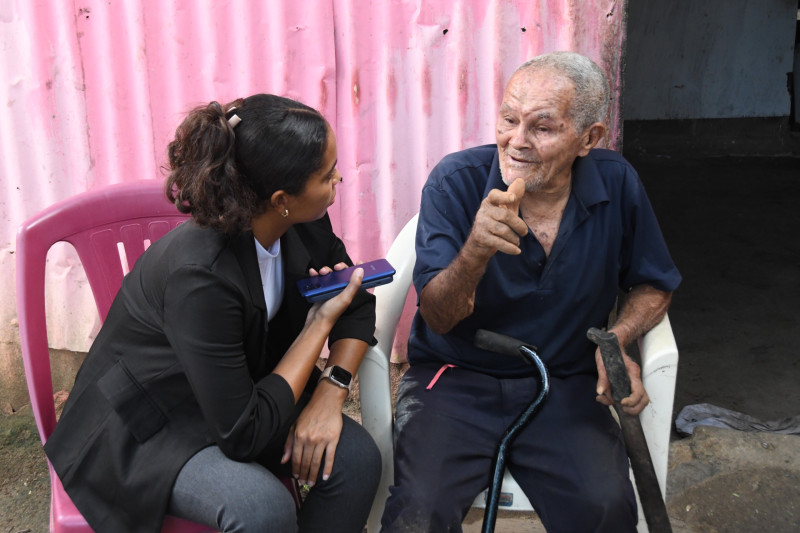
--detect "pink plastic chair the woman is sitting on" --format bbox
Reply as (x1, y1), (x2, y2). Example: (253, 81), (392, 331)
(16, 181), (216, 533)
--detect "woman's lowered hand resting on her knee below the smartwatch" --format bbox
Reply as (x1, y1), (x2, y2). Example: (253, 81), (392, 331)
(281, 382), (347, 487)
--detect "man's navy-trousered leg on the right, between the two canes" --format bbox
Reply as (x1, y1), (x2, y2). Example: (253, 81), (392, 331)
(504, 375), (637, 533)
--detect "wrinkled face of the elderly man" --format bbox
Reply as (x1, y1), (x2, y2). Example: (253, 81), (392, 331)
(496, 70), (581, 192)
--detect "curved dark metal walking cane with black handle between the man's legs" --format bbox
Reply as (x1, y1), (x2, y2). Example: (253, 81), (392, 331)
(475, 329), (550, 533)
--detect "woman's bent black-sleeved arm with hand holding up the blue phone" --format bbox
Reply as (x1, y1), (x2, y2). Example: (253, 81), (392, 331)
(164, 267), (363, 461)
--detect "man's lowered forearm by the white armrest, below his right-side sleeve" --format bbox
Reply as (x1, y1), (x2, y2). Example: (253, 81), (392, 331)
(610, 285), (672, 347)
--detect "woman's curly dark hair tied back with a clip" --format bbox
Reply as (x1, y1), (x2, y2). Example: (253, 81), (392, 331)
(166, 94), (328, 234)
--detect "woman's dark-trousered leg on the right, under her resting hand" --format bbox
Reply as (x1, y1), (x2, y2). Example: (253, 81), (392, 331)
(298, 415), (381, 533)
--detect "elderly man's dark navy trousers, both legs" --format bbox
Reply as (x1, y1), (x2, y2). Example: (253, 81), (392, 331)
(382, 365), (637, 533)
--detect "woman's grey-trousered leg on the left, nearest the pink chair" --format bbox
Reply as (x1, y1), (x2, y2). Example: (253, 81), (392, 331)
(168, 446), (297, 533)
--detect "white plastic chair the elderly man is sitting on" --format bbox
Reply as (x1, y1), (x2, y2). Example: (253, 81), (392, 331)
(358, 215), (678, 533)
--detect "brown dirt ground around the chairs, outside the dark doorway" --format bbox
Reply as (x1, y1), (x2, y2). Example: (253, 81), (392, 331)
(0, 371), (800, 533)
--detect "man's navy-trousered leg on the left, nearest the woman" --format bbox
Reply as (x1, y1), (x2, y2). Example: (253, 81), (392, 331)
(382, 365), (505, 533)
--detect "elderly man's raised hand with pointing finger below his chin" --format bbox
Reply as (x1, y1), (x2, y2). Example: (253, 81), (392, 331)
(465, 178), (528, 261)
